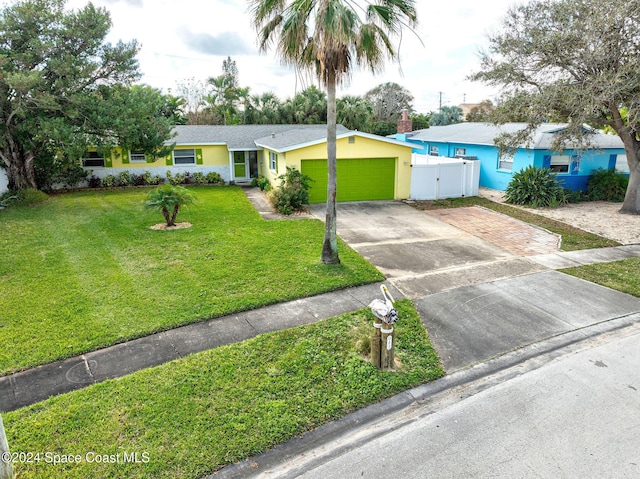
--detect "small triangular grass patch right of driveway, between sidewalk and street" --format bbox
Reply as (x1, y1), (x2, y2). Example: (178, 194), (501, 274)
(561, 258), (640, 297)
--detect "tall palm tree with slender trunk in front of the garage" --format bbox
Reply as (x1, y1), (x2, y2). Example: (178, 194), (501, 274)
(250, 0), (417, 264)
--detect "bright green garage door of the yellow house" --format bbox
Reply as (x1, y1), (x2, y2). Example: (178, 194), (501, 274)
(302, 158), (396, 203)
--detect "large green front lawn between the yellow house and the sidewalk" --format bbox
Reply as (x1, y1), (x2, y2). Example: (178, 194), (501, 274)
(0, 187), (383, 374)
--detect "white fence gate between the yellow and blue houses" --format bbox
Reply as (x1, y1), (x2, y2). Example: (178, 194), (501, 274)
(411, 153), (480, 200)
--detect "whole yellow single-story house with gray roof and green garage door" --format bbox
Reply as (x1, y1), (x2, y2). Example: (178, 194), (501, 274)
(83, 125), (413, 202)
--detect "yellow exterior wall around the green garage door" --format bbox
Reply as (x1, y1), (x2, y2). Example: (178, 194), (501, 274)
(261, 136), (411, 199)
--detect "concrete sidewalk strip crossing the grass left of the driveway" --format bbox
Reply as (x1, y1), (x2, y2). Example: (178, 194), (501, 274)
(0, 283), (402, 412)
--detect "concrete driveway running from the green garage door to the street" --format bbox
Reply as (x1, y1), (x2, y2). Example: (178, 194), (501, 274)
(311, 202), (640, 372)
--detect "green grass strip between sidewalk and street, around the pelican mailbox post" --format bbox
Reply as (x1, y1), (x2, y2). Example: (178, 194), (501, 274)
(4, 300), (444, 478)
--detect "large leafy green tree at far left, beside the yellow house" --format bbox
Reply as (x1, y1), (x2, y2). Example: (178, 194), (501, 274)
(0, 0), (175, 189)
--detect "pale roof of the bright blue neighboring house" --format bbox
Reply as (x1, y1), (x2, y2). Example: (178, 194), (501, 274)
(407, 123), (624, 149)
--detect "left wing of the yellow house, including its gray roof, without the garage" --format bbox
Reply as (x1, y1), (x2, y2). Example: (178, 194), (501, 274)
(83, 125), (344, 183)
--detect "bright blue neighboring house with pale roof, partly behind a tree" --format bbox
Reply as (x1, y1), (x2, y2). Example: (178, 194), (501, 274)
(395, 123), (629, 191)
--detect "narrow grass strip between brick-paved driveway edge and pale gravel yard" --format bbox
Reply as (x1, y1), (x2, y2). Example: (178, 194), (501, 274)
(415, 196), (620, 251)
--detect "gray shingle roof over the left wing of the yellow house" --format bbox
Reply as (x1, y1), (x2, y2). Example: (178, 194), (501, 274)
(171, 125), (340, 150)
